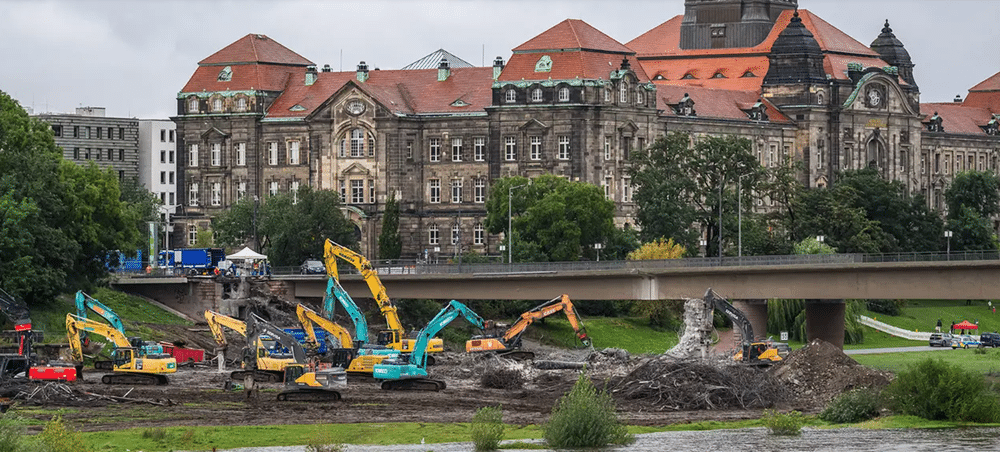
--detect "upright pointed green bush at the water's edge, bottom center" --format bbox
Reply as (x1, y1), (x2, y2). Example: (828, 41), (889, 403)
(545, 372), (635, 449)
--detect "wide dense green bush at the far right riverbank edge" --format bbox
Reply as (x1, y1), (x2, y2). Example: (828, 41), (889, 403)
(882, 358), (1000, 423)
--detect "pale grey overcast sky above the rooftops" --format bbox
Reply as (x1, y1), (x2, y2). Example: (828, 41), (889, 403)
(0, 0), (1000, 119)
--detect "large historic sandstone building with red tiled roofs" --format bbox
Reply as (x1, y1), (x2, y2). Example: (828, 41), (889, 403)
(172, 0), (1000, 258)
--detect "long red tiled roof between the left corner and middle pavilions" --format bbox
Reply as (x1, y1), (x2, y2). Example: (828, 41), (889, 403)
(267, 67), (493, 118)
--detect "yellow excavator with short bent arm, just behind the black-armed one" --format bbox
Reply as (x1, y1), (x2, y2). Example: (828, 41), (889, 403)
(205, 310), (296, 381)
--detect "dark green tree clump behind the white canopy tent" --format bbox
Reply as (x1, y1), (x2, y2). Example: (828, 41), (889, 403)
(212, 187), (358, 266)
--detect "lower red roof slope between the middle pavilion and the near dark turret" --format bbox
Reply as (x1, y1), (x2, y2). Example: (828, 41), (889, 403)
(656, 85), (791, 123)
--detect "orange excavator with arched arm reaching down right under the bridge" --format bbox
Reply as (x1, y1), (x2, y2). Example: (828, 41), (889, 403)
(465, 294), (592, 360)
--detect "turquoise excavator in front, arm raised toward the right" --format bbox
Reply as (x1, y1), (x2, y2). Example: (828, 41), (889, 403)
(372, 300), (486, 391)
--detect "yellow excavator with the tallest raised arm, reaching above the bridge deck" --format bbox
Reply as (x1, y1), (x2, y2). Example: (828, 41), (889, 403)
(323, 239), (444, 365)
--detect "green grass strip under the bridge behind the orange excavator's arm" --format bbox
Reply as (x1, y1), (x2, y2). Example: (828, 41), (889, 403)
(525, 317), (677, 354)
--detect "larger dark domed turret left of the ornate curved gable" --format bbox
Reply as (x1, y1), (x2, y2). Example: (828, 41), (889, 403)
(764, 11), (826, 85)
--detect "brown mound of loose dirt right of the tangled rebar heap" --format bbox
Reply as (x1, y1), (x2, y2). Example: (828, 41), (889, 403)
(770, 339), (892, 408)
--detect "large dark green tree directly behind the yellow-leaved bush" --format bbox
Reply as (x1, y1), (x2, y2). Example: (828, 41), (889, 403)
(628, 132), (768, 255)
